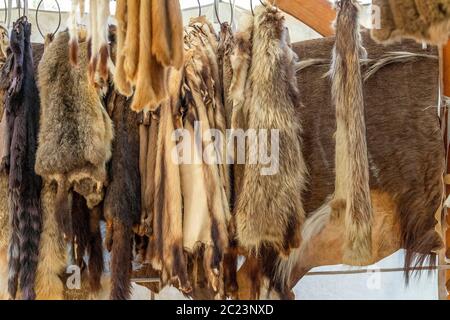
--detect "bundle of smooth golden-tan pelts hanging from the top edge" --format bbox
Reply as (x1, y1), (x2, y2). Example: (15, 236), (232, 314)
(114, 0), (183, 112)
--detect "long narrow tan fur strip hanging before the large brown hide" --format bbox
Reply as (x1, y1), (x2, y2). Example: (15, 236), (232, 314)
(330, 0), (373, 265)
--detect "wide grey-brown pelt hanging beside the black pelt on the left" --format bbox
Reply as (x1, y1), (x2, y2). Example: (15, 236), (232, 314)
(35, 32), (113, 236)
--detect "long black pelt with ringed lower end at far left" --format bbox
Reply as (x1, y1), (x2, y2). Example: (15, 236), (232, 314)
(5, 18), (41, 299)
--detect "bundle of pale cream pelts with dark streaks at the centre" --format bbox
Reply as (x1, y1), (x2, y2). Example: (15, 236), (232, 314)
(179, 17), (234, 298)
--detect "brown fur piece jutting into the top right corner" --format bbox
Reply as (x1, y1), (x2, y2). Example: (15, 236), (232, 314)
(372, 0), (450, 44)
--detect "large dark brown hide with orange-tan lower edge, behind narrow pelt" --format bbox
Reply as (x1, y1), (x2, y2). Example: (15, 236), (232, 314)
(265, 32), (445, 296)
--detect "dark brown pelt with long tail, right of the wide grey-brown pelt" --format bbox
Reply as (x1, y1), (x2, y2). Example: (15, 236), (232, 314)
(103, 87), (141, 299)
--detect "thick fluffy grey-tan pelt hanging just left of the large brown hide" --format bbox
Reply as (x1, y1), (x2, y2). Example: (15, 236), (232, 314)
(235, 5), (306, 254)
